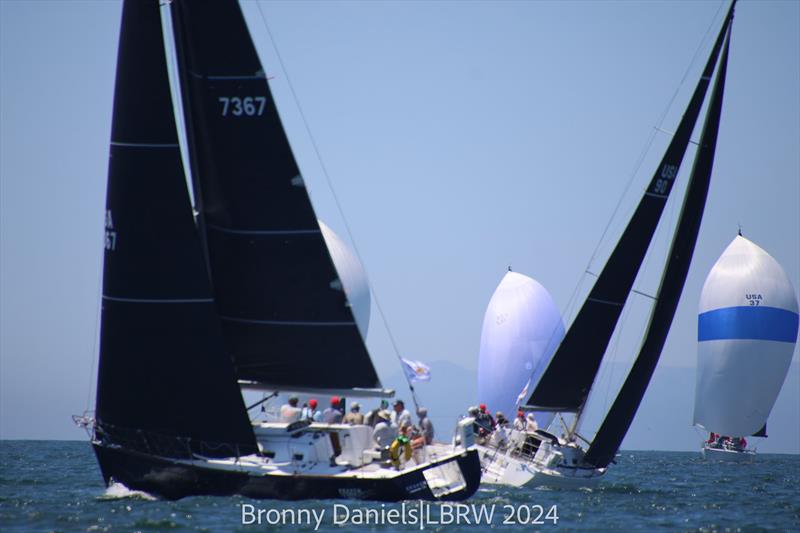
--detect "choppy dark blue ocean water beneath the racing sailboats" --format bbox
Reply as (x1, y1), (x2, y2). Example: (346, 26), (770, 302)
(0, 441), (800, 533)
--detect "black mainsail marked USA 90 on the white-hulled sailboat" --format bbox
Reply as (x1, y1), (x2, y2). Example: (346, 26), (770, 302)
(527, 0), (733, 412)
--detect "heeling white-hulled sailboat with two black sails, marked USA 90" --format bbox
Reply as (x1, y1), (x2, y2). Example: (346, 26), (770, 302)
(481, 0), (735, 487)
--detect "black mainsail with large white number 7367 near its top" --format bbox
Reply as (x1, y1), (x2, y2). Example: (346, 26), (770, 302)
(172, 0), (381, 390)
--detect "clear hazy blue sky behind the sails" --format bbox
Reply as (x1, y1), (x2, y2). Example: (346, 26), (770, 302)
(0, 0), (800, 453)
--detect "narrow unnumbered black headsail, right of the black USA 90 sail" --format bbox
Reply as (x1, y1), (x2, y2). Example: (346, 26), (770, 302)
(584, 12), (733, 468)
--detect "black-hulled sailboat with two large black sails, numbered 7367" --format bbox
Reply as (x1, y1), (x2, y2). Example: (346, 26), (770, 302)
(75, 0), (480, 501)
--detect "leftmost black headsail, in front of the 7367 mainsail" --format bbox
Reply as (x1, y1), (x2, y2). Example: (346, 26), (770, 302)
(96, 1), (256, 457)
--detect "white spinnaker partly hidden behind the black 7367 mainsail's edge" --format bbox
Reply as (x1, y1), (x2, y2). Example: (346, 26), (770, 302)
(317, 220), (371, 334)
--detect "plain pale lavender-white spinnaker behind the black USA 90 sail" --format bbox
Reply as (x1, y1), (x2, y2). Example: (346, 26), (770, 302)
(478, 272), (564, 428)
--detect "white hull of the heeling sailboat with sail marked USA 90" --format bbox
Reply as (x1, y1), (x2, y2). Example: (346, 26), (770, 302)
(478, 432), (606, 489)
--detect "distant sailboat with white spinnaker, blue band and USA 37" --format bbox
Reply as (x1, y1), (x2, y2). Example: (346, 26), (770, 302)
(694, 233), (798, 461)
